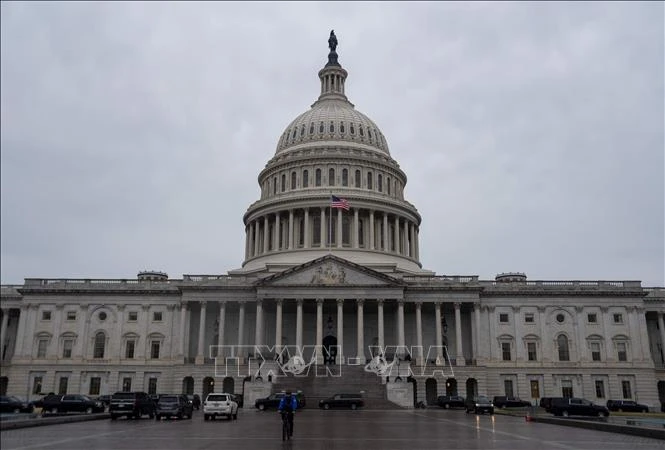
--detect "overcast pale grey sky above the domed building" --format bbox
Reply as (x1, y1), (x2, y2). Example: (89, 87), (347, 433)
(0, 2), (665, 286)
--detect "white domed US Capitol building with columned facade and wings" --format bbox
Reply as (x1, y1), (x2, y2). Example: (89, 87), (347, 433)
(0, 33), (665, 410)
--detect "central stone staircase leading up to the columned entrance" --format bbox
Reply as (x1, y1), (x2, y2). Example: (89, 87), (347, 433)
(272, 365), (400, 409)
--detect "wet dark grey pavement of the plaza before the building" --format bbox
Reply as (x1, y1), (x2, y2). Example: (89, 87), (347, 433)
(0, 409), (665, 450)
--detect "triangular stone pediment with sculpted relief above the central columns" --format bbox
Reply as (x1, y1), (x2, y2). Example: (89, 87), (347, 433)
(258, 255), (401, 287)
